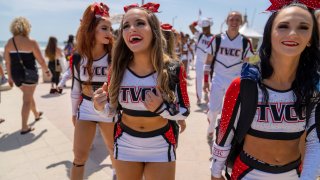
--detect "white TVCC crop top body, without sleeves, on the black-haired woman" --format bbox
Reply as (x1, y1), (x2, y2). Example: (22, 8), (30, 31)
(248, 85), (306, 140)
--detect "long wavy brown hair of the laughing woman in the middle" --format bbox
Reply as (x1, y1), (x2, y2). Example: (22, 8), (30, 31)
(108, 7), (175, 109)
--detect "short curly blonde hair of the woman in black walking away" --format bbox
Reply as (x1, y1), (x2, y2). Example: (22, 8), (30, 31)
(10, 16), (31, 37)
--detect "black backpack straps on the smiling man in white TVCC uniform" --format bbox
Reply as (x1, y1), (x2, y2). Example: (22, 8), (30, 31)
(208, 34), (252, 77)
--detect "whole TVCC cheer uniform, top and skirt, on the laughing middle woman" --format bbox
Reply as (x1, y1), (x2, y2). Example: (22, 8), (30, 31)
(96, 66), (189, 162)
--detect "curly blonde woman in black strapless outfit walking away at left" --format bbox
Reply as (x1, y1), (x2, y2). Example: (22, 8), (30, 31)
(4, 17), (51, 134)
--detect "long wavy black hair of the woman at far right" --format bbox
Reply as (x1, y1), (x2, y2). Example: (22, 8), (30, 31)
(259, 3), (320, 118)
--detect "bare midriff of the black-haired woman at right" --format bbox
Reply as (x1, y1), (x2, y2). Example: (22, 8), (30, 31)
(243, 135), (301, 166)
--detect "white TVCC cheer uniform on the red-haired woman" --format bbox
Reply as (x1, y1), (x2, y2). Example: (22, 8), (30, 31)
(71, 54), (115, 122)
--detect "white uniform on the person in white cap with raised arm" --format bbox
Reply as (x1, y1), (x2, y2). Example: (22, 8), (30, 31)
(194, 31), (213, 102)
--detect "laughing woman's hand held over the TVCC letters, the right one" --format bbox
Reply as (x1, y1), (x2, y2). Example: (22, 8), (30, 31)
(143, 88), (163, 112)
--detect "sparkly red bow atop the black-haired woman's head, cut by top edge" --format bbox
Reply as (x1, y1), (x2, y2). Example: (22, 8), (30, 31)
(266, 0), (320, 11)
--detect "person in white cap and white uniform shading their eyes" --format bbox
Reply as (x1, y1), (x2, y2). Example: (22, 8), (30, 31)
(189, 18), (213, 105)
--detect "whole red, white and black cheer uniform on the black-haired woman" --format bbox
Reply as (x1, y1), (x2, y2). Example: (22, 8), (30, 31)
(211, 79), (320, 180)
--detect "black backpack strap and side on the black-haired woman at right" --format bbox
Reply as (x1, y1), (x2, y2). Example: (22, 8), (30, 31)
(221, 79), (258, 180)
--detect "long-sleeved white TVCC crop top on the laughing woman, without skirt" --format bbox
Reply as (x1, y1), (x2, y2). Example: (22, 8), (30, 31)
(97, 63), (190, 120)
